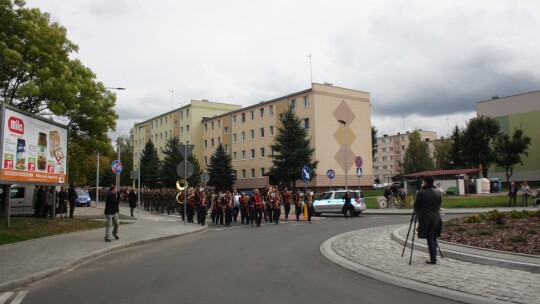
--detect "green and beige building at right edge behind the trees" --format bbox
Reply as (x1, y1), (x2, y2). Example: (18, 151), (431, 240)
(476, 91), (540, 181)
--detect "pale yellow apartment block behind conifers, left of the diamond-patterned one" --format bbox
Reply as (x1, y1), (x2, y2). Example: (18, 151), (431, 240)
(131, 100), (241, 170)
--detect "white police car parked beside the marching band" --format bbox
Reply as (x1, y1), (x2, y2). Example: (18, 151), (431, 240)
(313, 190), (366, 216)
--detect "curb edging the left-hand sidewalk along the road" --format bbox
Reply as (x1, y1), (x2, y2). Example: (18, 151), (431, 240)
(0, 225), (210, 292)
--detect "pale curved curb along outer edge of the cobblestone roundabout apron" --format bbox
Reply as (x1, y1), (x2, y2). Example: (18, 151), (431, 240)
(320, 230), (507, 304)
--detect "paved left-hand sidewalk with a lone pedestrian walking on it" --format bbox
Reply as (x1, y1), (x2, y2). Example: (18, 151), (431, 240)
(0, 203), (208, 292)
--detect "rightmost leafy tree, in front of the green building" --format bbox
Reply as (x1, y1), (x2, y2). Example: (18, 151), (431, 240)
(493, 129), (531, 184)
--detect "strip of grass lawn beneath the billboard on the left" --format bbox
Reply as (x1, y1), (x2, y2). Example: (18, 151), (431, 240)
(0, 217), (131, 245)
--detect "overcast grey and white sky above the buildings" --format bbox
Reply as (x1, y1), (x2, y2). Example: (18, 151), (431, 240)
(26, 0), (540, 137)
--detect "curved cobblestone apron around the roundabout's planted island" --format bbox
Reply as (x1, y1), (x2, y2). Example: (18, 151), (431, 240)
(321, 225), (540, 303)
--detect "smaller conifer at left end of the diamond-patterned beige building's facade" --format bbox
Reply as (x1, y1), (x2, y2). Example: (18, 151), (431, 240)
(207, 143), (236, 191)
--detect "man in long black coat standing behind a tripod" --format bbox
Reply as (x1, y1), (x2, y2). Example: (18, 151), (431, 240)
(414, 176), (442, 264)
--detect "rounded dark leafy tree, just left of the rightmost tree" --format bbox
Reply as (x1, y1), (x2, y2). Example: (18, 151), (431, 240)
(460, 116), (500, 178)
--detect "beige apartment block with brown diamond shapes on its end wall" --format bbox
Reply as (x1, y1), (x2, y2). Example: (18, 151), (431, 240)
(198, 83), (373, 190)
